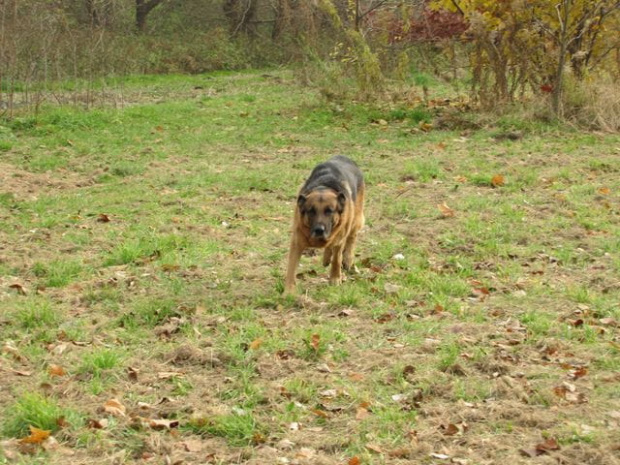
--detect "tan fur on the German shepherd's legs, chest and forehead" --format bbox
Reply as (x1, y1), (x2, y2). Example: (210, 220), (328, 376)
(285, 185), (364, 293)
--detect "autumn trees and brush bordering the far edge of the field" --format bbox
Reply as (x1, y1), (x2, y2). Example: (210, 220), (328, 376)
(0, 0), (620, 126)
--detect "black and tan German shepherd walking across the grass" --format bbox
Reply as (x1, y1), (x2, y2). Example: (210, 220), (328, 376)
(284, 155), (364, 293)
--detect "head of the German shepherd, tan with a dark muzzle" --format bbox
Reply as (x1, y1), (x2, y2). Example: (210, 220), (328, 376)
(297, 189), (347, 244)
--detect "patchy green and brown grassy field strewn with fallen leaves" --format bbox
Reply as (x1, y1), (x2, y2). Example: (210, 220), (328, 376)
(0, 72), (620, 465)
